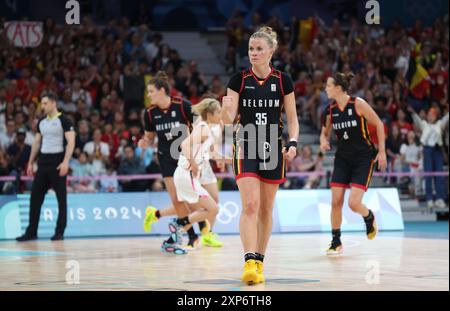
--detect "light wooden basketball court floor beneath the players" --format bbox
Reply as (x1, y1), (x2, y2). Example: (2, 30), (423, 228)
(0, 233), (449, 291)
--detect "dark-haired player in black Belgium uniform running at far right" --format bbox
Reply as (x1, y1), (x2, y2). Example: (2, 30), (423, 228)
(320, 73), (386, 255)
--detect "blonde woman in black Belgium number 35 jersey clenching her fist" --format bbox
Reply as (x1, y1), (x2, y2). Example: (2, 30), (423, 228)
(222, 27), (299, 285)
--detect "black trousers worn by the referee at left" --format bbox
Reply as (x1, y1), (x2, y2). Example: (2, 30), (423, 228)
(26, 154), (67, 235)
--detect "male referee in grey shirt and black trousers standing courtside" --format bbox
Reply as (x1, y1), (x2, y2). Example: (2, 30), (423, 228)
(16, 93), (75, 242)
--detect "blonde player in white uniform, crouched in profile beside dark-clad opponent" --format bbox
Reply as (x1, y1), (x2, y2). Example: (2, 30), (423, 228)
(169, 99), (230, 246)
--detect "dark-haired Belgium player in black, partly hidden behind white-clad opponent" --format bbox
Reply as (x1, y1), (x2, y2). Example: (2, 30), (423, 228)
(139, 71), (195, 254)
